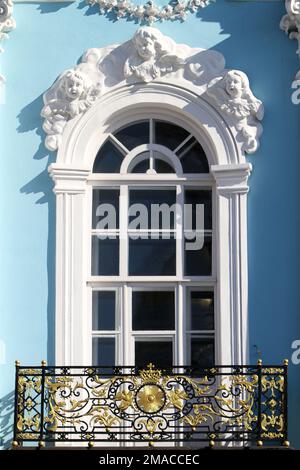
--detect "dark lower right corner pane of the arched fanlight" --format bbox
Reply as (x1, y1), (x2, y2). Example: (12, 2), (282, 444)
(179, 141), (209, 173)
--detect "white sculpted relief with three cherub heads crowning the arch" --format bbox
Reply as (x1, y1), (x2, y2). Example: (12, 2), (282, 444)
(41, 26), (263, 153)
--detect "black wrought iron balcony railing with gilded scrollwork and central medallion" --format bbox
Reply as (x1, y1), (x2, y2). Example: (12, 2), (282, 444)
(13, 361), (288, 447)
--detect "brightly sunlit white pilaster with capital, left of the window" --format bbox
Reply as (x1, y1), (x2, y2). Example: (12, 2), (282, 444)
(49, 164), (90, 366)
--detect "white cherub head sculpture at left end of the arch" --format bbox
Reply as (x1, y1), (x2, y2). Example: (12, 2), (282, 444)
(41, 69), (101, 150)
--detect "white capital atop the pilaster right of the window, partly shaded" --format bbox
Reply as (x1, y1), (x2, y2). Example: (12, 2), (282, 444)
(211, 163), (252, 195)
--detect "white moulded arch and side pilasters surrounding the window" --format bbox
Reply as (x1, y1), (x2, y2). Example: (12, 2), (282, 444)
(49, 86), (251, 365)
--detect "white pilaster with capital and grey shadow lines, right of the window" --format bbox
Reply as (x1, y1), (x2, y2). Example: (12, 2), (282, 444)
(211, 163), (251, 365)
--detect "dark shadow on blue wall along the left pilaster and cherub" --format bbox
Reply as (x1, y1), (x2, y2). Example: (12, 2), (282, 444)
(17, 95), (55, 364)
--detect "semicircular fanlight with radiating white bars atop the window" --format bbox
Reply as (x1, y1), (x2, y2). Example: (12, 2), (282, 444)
(93, 119), (209, 175)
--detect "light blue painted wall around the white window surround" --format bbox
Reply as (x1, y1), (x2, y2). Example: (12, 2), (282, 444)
(0, 0), (300, 448)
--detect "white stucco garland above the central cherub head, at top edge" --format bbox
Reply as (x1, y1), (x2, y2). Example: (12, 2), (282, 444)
(86, 0), (215, 24)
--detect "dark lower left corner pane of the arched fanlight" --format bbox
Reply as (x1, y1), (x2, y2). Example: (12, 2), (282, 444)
(93, 140), (124, 173)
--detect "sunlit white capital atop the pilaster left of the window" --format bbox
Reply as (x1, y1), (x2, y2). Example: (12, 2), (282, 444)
(48, 163), (90, 194)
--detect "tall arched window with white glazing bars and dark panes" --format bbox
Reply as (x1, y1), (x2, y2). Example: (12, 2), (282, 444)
(90, 118), (215, 367)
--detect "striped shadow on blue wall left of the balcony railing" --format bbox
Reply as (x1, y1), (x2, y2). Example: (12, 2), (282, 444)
(0, 391), (15, 450)
